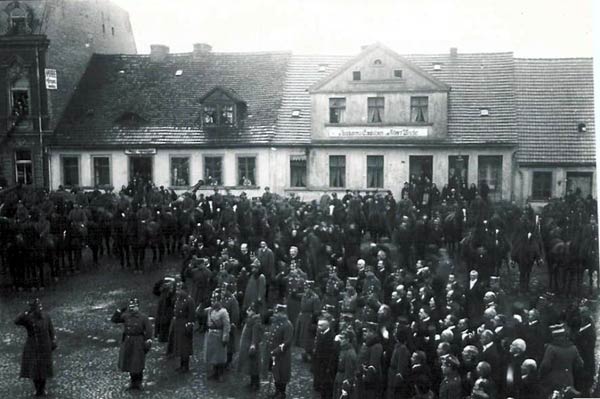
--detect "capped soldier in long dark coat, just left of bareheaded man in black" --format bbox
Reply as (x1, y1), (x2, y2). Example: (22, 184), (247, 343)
(267, 305), (294, 399)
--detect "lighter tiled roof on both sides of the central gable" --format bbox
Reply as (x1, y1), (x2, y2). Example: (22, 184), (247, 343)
(274, 53), (517, 144)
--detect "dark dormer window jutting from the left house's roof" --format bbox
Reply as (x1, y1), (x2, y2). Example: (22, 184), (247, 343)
(200, 87), (246, 127)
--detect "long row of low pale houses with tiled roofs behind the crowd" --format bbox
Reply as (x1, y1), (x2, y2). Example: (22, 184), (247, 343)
(48, 44), (596, 202)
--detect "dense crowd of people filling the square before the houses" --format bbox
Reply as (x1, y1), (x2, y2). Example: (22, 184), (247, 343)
(2, 179), (596, 399)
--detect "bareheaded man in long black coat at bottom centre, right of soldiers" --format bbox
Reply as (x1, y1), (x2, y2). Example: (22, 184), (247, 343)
(312, 318), (336, 398)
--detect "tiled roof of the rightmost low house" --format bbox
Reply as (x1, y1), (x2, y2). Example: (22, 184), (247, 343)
(515, 58), (596, 164)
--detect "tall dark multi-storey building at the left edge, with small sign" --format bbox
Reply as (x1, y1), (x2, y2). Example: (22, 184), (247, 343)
(0, 0), (136, 186)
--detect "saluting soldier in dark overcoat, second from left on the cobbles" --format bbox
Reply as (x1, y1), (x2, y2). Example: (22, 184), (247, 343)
(112, 298), (152, 390)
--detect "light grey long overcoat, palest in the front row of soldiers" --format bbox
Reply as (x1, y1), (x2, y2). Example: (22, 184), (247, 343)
(203, 307), (231, 365)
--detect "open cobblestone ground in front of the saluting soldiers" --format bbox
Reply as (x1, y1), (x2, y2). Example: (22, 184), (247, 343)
(0, 258), (312, 399)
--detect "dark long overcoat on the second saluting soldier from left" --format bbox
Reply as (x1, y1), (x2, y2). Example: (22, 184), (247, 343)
(112, 310), (152, 373)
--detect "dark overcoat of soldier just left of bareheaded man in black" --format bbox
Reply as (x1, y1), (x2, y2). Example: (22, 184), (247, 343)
(267, 314), (294, 384)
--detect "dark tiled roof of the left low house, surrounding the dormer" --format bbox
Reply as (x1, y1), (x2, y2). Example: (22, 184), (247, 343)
(51, 52), (290, 147)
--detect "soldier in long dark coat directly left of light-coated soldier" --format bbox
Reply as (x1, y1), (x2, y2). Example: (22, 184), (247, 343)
(167, 281), (196, 373)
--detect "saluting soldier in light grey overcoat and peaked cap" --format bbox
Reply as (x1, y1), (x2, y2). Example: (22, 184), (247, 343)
(196, 288), (231, 382)
